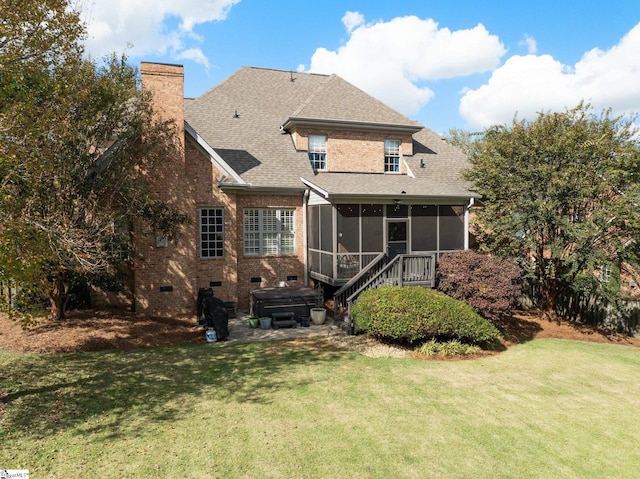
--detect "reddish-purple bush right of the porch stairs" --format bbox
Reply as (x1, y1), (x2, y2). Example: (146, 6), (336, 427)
(437, 250), (522, 321)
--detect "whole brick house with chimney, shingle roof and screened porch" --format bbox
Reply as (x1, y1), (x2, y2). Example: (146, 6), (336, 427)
(134, 62), (478, 314)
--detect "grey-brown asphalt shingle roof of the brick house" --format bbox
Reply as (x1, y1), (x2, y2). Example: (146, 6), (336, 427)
(185, 67), (475, 197)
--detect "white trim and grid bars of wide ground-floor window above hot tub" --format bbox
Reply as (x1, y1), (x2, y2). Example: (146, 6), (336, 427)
(243, 208), (297, 257)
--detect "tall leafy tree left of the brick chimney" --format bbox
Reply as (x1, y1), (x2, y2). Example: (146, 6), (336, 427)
(0, 0), (185, 318)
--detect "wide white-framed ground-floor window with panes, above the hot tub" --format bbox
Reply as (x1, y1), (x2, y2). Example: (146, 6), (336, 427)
(243, 208), (296, 256)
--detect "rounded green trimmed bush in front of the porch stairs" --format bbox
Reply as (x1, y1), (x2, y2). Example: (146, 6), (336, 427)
(351, 286), (500, 344)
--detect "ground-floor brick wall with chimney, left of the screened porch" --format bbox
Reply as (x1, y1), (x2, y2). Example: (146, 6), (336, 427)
(134, 63), (316, 316)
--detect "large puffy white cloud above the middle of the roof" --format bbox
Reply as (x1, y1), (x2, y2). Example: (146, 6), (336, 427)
(309, 12), (506, 115)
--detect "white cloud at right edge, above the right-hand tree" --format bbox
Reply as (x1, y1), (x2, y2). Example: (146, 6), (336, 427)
(460, 23), (640, 128)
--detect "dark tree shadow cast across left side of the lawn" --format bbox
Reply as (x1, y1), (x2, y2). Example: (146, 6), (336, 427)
(0, 340), (350, 438)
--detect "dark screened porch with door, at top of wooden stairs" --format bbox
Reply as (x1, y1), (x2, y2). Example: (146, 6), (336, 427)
(307, 204), (467, 286)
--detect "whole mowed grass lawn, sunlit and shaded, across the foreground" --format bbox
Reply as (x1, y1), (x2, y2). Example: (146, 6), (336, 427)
(0, 340), (640, 478)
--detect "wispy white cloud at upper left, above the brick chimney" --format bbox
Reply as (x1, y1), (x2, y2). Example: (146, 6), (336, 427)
(77, 0), (240, 66)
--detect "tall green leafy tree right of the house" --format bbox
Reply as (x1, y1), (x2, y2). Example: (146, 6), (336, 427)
(451, 104), (640, 313)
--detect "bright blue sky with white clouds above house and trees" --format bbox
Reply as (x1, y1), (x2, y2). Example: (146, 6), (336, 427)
(77, 0), (640, 133)
